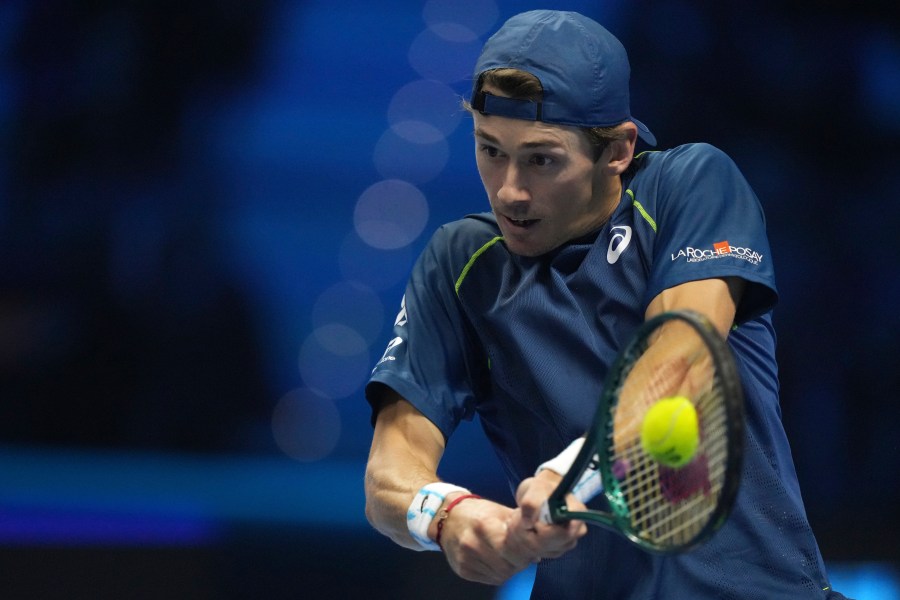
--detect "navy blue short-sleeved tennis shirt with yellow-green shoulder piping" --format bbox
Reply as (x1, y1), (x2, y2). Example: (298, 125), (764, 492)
(366, 144), (828, 599)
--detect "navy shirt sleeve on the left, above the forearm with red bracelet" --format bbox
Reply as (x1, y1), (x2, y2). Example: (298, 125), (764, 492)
(366, 226), (486, 438)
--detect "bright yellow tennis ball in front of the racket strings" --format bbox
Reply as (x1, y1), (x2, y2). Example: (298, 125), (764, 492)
(641, 396), (700, 469)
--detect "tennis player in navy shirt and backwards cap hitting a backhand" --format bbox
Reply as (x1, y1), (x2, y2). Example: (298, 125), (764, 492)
(365, 11), (842, 600)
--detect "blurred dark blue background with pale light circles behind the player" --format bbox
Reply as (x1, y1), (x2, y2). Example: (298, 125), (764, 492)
(0, 0), (900, 599)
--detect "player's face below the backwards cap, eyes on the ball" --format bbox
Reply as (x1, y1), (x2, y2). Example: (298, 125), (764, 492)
(474, 102), (620, 256)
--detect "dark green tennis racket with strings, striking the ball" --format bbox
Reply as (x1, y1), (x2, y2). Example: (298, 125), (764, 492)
(542, 311), (744, 553)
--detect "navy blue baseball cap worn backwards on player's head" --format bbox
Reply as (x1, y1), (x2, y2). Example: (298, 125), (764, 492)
(471, 10), (656, 146)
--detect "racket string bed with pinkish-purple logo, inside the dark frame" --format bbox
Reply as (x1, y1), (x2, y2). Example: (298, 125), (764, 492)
(607, 334), (728, 547)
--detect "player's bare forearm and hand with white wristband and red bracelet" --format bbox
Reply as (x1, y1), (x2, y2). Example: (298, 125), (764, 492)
(365, 390), (536, 585)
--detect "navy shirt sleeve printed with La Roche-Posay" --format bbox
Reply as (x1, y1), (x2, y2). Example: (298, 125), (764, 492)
(645, 144), (777, 323)
